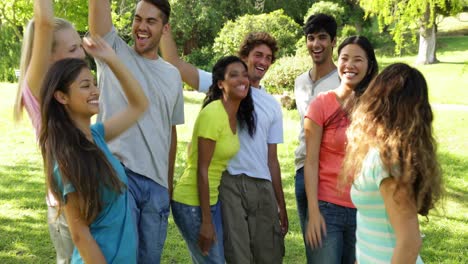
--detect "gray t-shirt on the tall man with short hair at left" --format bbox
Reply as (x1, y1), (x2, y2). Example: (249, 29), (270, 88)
(96, 28), (184, 188)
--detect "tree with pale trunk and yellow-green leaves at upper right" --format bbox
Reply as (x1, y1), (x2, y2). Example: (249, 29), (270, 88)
(359, 0), (462, 64)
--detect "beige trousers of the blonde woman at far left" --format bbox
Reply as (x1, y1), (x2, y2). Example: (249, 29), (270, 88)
(47, 206), (75, 264)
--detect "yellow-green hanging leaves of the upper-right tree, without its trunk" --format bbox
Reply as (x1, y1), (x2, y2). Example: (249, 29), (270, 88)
(359, 0), (462, 54)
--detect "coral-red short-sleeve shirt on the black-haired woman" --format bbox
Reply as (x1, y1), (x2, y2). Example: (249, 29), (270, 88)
(305, 91), (354, 208)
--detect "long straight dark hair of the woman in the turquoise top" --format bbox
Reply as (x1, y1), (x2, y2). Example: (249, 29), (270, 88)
(39, 58), (125, 223)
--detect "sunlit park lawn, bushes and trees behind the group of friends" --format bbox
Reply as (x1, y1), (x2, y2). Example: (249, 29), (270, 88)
(0, 0), (468, 263)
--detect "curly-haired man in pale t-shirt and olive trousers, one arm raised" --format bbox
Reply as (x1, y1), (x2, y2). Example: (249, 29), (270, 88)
(161, 32), (288, 263)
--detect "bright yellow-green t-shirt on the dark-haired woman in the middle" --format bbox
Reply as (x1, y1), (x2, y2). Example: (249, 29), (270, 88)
(173, 100), (239, 206)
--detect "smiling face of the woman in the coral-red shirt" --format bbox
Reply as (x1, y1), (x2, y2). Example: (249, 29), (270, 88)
(338, 44), (368, 90)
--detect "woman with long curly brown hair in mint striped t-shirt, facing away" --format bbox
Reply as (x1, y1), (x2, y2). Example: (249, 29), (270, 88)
(341, 63), (442, 263)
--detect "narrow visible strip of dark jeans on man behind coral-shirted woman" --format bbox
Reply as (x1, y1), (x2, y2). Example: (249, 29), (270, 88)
(295, 167), (312, 263)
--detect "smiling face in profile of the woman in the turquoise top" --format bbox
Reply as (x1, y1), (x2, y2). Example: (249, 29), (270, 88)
(58, 68), (100, 120)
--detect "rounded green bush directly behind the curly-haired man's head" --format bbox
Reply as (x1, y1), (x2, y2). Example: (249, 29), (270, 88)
(213, 10), (301, 57)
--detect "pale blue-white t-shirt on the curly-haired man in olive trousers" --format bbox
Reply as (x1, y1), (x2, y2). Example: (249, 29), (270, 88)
(198, 69), (283, 181)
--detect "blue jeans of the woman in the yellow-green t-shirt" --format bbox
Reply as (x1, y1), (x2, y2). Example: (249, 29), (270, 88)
(171, 201), (225, 264)
